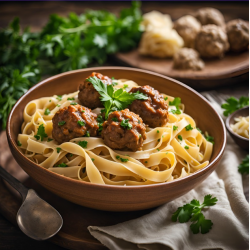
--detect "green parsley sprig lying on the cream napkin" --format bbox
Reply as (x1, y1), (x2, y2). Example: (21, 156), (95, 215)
(171, 194), (218, 234)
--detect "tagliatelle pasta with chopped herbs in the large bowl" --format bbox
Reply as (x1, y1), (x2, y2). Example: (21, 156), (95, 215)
(18, 79), (213, 185)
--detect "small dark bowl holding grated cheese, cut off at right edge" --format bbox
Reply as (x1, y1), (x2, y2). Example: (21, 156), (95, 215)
(226, 106), (249, 150)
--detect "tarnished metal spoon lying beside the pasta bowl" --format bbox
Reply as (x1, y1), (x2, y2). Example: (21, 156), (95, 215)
(0, 166), (63, 240)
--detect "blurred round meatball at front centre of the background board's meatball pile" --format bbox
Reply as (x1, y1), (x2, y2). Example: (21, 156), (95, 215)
(195, 24), (229, 58)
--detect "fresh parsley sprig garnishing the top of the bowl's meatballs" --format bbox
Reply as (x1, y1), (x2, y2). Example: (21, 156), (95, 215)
(87, 76), (148, 119)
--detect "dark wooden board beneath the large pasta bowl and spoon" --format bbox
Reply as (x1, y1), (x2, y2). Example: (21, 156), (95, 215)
(0, 132), (151, 250)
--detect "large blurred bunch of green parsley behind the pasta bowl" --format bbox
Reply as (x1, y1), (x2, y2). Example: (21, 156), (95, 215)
(0, 1), (142, 129)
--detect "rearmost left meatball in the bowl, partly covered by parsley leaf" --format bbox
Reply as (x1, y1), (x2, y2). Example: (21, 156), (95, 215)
(78, 72), (112, 109)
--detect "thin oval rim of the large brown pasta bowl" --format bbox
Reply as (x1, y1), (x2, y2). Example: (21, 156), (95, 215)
(7, 66), (226, 191)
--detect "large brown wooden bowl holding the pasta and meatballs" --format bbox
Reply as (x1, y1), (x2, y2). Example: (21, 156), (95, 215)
(7, 67), (226, 211)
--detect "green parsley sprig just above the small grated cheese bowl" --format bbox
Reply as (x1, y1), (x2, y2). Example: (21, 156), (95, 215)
(221, 96), (249, 116)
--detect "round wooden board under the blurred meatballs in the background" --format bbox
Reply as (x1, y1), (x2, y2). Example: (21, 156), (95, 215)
(115, 49), (249, 89)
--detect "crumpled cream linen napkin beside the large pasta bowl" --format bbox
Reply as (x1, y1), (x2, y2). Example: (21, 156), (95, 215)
(88, 100), (249, 250)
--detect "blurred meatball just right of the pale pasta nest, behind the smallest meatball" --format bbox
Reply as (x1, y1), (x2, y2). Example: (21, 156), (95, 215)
(174, 15), (201, 48)
